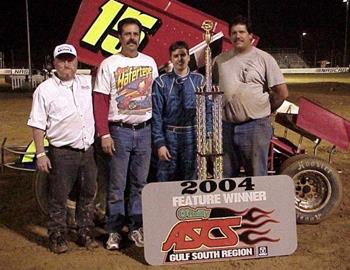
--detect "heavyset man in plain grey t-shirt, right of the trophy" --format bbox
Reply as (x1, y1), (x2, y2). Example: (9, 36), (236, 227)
(213, 16), (288, 177)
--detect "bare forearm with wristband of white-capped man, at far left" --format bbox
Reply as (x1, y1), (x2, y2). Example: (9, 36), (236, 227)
(32, 127), (52, 173)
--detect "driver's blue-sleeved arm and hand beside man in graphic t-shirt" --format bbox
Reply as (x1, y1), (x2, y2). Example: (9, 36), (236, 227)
(152, 79), (171, 160)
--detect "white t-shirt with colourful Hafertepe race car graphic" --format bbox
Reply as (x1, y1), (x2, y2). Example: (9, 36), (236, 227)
(94, 52), (158, 124)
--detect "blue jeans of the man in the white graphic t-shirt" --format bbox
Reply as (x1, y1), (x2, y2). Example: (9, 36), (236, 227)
(107, 125), (151, 233)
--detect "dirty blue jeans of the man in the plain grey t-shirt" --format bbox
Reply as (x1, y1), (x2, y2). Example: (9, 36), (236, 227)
(223, 117), (272, 177)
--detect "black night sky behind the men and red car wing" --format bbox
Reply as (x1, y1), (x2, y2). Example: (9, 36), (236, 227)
(0, 0), (346, 68)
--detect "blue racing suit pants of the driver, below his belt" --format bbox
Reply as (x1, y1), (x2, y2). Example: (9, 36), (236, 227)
(157, 127), (196, 182)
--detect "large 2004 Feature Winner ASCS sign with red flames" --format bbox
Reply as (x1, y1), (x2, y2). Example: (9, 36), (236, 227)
(142, 175), (297, 265)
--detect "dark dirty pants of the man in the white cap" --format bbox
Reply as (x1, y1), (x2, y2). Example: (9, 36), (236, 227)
(48, 146), (97, 235)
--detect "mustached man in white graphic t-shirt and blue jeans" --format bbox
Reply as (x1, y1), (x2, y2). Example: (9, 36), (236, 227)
(94, 18), (158, 250)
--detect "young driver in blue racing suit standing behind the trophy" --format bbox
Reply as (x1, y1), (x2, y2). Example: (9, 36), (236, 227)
(152, 41), (211, 182)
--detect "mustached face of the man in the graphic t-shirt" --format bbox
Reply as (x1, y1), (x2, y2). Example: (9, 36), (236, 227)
(119, 24), (140, 52)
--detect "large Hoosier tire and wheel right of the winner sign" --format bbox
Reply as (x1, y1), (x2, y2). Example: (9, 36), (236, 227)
(281, 155), (343, 224)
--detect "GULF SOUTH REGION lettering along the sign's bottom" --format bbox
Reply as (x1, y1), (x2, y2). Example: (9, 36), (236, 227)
(166, 247), (254, 262)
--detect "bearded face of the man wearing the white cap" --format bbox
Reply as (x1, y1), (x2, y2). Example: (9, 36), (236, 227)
(53, 54), (78, 81)
